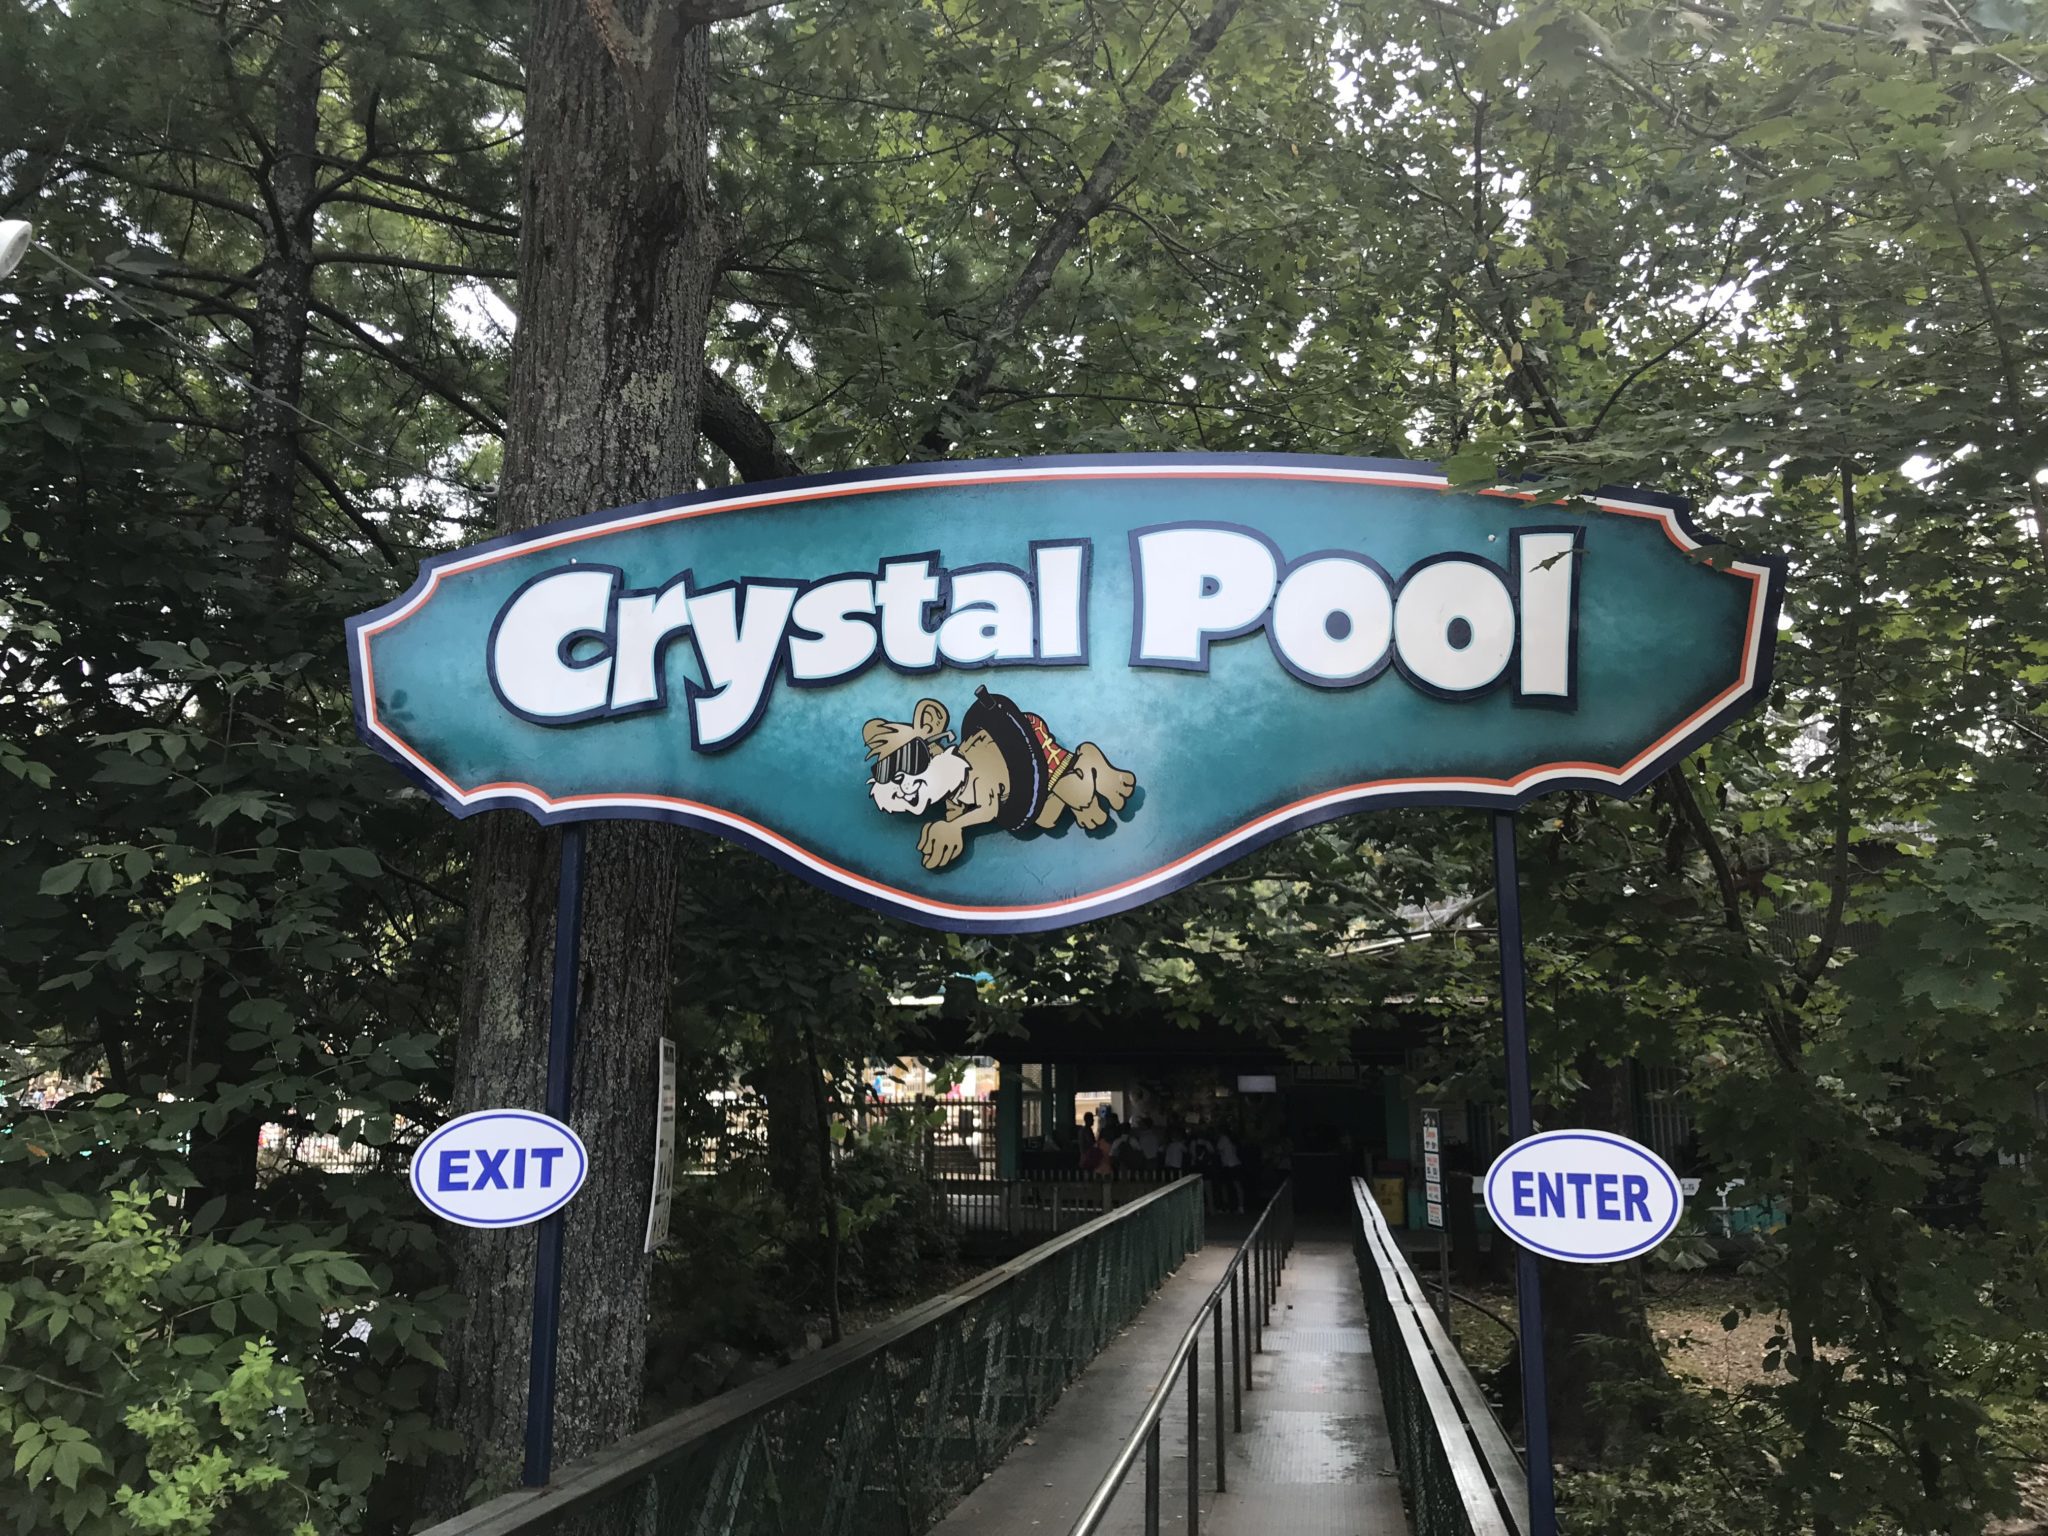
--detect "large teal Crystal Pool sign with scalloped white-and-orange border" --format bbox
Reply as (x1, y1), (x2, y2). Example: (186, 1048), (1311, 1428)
(348, 455), (1784, 932)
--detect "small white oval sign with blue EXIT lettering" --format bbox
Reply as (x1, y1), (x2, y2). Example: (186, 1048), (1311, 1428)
(412, 1110), (590, 1227)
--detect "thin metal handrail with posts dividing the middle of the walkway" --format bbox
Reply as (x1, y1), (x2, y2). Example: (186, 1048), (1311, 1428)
(1069, 1182), (1294, 1536)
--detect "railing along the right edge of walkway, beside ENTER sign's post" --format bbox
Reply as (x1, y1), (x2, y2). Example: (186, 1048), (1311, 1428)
(1352, 1180), (1530, 1536)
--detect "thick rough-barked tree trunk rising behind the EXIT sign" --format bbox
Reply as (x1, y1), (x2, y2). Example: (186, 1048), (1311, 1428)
(436, 0), (719, 1507)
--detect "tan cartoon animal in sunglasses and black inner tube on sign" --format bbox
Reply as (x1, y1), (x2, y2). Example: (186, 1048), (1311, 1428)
(860, 688), (1139, 868)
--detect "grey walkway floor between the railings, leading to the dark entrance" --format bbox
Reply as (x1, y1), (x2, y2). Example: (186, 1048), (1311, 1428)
(934, 1239), (1409, 1536)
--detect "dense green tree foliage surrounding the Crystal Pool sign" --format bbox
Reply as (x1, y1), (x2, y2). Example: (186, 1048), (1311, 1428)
(0, 0), (2048, 1536)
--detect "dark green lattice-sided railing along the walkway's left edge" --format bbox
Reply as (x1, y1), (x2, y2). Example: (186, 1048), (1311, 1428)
(422, 1178), (1204, 1536)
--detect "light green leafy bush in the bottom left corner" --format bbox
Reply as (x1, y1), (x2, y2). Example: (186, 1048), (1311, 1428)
(0, 1188), (452, 1536)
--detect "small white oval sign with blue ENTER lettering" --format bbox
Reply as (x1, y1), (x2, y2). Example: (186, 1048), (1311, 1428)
(1487, 1130), (1686, 1264)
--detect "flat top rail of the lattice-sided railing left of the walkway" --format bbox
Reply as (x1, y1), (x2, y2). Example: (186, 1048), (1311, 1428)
(420, 1174), (1202, 1536)
